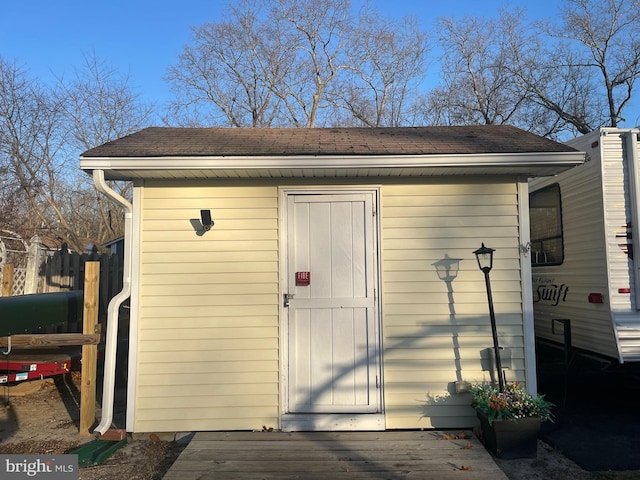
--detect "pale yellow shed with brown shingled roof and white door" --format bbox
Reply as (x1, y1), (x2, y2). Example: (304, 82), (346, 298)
(80, 125), (584, 433)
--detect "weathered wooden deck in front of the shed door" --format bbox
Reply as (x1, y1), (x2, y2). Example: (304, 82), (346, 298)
(164, 431), (507, 480)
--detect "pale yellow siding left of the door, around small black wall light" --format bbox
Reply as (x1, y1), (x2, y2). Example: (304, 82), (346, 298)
(134, 182), (279, 432)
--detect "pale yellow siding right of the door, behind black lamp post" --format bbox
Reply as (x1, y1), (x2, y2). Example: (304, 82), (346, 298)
(381, 181), (524, 428)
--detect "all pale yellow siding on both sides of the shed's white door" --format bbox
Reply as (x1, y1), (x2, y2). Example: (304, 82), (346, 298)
(134, 179), (524, 432)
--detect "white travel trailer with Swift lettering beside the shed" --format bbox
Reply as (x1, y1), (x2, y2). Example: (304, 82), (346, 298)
(529, 128), (640, 363)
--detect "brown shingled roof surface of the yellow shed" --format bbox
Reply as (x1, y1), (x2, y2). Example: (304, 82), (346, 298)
(82, 125), (575, 158)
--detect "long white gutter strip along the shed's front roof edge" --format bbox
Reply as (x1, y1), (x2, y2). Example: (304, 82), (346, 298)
(80, 152), (584, 171)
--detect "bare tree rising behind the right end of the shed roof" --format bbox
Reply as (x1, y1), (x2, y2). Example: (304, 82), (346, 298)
(422, 9), (556, 135)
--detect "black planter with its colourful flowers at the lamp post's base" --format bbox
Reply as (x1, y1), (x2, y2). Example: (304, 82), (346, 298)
(471, 383), (553, 459)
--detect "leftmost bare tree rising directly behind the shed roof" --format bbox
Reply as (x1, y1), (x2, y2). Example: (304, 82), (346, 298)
(165, 0), (294, 127)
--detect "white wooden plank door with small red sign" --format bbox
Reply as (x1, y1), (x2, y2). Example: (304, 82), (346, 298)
(285, 193), (380, 413)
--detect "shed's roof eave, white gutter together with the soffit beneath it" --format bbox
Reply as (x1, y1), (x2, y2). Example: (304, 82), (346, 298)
(80, 151), (584, 179)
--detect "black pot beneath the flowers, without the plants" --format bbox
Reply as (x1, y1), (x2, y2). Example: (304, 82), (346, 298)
(476, 410), (541, 459)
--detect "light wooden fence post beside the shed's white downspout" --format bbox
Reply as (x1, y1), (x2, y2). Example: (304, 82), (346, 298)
(80, 262), (100, 435)
